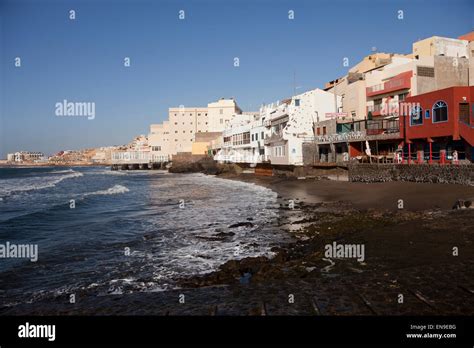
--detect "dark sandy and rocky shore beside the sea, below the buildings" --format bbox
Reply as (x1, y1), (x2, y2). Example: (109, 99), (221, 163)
(0, 170), (474, 315)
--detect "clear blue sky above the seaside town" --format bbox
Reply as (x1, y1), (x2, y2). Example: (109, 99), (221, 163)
(0, 0), (474, 158)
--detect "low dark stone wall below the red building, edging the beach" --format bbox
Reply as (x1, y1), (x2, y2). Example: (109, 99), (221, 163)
(349, 163), (474, 186)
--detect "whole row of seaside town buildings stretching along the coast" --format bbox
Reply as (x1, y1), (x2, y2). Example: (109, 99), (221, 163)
(3, 32), (474, 169)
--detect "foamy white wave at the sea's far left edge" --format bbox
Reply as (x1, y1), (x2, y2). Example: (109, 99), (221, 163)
(0, 171), (83, 196)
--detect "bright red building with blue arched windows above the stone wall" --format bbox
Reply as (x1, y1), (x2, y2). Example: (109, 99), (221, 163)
(400, 86), (474, 162)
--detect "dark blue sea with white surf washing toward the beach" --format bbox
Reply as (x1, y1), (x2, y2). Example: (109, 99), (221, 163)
(0, 167), (284, 306)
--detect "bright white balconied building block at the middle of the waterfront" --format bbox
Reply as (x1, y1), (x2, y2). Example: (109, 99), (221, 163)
(214, 89), (341, 165)
